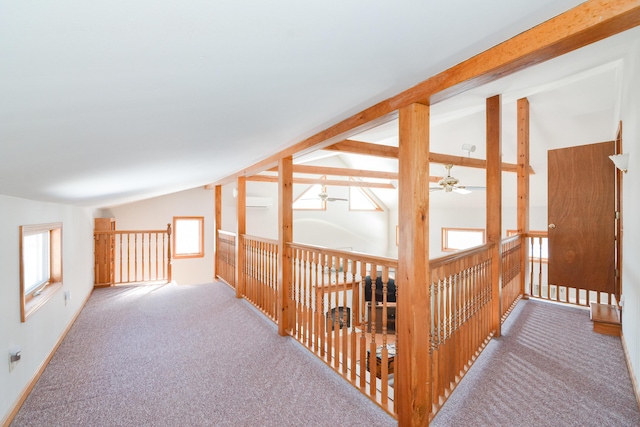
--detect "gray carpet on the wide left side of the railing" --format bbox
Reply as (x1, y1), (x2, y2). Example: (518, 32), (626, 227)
(12, 283), (397, 426)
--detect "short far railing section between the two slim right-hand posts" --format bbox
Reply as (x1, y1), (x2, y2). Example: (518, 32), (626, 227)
(500, 235), (524, 321)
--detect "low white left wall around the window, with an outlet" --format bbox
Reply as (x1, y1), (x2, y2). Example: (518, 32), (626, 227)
(0, 195), (93, 424)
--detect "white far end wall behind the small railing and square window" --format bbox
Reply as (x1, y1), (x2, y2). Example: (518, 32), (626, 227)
(101, 187), (214, 285)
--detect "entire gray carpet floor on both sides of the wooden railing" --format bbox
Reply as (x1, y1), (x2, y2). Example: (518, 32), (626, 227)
(11, 283), (640, 427)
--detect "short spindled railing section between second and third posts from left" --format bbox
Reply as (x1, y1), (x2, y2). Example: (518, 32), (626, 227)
(242, 235), (278, 322)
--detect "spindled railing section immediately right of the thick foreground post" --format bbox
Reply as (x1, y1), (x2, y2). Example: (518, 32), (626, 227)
(430, 245), (493, 416)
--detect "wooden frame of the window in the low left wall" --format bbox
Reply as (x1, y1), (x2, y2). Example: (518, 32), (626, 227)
(20, 222), (62, 322)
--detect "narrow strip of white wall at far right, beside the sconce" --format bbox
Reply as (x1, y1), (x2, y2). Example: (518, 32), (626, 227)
(621, 41), (640, 394)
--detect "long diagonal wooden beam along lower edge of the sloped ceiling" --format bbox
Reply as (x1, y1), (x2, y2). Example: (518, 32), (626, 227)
(207, 0), (640, 189)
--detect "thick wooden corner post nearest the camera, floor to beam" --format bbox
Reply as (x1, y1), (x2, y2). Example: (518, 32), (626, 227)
(395, 104), (432, 426)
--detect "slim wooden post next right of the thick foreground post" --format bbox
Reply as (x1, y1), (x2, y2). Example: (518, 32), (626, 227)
(487, 95), (502, 337)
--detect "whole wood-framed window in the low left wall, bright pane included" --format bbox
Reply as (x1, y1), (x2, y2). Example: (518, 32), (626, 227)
(20, 223), (62, 322)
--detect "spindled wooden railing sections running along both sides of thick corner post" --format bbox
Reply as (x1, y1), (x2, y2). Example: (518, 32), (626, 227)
(218, 236), (524, 416)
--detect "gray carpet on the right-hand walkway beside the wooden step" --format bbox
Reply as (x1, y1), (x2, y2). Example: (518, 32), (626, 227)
(431, 300), (640, 427)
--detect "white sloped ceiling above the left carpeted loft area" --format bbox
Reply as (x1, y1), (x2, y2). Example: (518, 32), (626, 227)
(0, 0), (632, 207)
